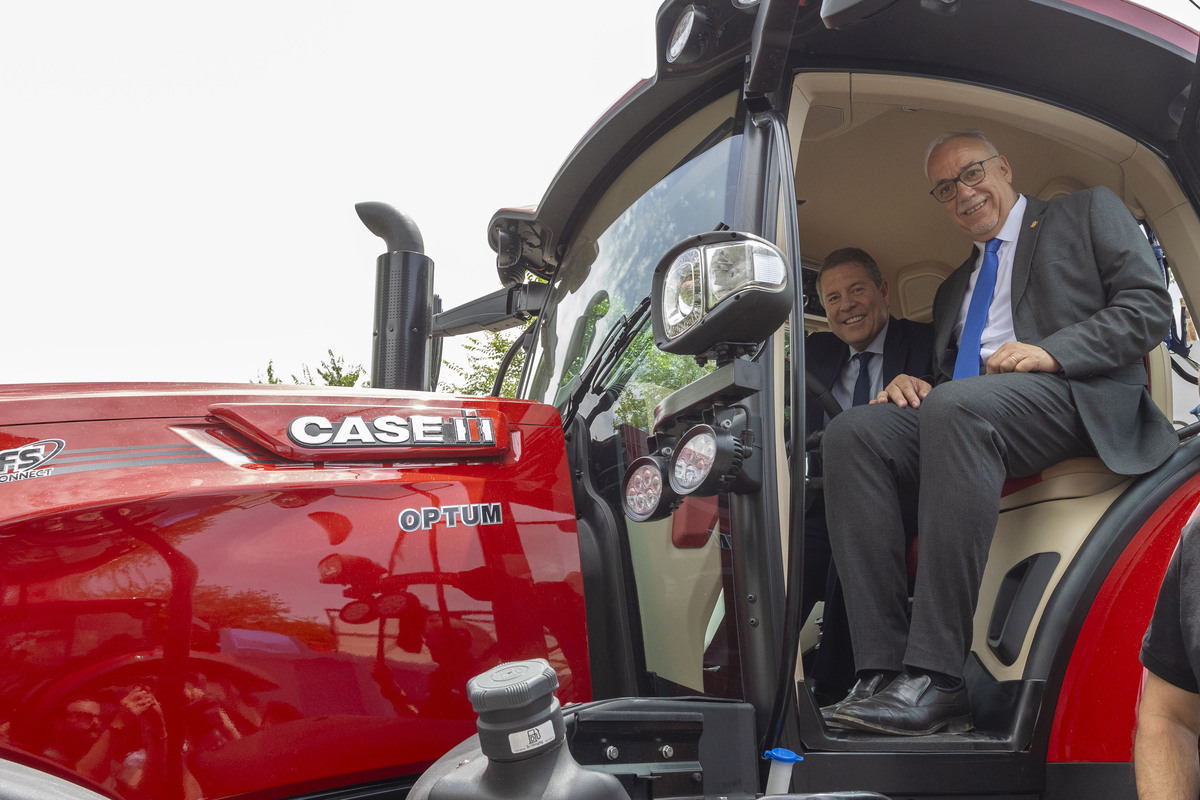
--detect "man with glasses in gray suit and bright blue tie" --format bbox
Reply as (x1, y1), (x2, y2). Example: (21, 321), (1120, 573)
(822, 131), (1178, 735)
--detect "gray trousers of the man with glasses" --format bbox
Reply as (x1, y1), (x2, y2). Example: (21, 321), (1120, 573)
(822, 373), (1094, 676)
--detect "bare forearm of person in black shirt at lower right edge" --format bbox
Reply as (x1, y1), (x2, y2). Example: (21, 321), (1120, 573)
(1133, 670), (1200, 800)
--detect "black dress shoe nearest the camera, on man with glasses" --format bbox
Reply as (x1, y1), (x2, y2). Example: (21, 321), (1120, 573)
(832, 673), (974, 736)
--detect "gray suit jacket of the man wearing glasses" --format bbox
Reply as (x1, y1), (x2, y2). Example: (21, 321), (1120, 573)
(934, 187), (1178, 475)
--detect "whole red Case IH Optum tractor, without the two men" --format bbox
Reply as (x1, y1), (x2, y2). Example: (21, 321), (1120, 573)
(0, 0), (1200, 800)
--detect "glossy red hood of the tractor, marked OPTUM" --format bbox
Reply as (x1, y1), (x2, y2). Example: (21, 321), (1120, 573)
(0, 387), (590, 799)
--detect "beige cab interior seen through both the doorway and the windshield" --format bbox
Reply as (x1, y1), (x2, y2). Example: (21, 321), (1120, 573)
(614, 72), (1200, 691)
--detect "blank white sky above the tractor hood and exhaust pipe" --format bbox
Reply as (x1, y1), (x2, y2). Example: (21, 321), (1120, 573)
(0, 0), (1200, 383)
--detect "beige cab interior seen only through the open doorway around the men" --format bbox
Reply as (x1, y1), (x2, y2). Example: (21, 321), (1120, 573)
(788, 73), (1200, 680)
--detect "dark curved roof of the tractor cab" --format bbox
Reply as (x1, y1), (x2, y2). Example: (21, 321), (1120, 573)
(488, 0), (1198, 277)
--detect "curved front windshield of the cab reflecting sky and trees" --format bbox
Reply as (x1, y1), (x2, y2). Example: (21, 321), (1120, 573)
(527, 95), (742, 697)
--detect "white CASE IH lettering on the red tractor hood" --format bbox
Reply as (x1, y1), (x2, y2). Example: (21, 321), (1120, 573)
(288, 411), (496, 447)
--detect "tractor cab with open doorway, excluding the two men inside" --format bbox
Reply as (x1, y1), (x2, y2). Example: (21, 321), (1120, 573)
(408, 0), (1200, 798)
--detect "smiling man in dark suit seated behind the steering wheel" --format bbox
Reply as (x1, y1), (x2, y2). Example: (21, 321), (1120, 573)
(803, 247), (934, 704)
